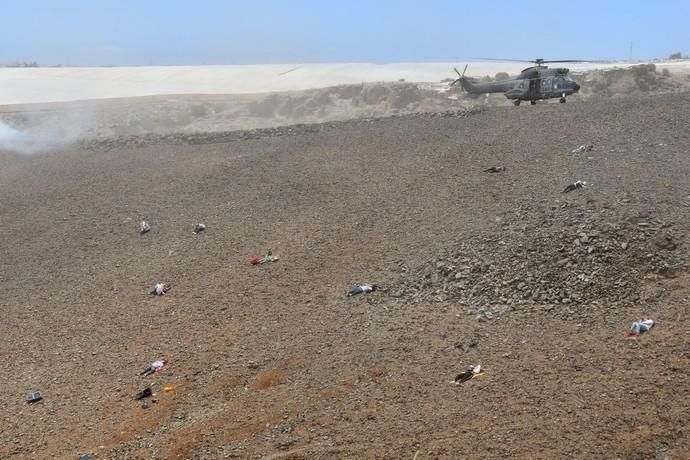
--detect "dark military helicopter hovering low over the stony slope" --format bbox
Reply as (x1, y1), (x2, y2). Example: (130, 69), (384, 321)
(450, 58), (593, 106)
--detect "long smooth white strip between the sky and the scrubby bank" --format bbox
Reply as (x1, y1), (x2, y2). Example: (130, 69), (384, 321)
(0, 61), (688, 105)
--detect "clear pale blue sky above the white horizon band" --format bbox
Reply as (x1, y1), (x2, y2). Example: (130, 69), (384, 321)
(0, 0), (690, 65)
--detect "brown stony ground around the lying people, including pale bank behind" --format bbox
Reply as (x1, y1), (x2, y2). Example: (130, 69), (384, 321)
(0, 66), (690, 460)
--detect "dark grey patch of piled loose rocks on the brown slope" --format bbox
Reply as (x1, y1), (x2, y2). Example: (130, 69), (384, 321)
(390, 208), (684, 322)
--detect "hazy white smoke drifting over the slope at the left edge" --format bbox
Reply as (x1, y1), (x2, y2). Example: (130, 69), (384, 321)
(0, 110), (95, 154)
